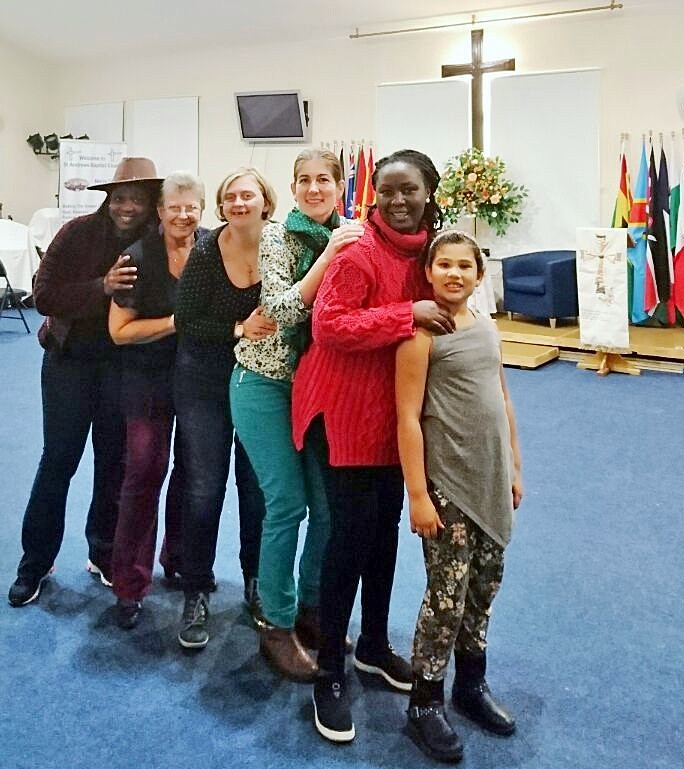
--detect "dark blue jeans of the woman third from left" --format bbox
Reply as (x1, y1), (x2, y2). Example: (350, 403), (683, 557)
(174, 347), (265, 592)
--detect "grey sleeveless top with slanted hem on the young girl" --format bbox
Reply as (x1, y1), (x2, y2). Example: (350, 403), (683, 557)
(421, 315), (513, 547)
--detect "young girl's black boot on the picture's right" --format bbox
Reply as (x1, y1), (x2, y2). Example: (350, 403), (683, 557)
(451, 652), (515, 736)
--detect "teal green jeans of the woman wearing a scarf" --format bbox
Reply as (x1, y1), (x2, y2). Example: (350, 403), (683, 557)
(230, 365), (330, 628)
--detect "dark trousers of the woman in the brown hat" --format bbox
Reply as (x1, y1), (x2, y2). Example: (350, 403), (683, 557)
(18, 350), (125, 578)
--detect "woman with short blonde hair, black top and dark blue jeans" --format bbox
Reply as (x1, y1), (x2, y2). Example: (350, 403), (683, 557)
(174, 168), (276, 648)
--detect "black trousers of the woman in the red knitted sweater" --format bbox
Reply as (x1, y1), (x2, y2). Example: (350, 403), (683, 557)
(307, 419), (404, 676)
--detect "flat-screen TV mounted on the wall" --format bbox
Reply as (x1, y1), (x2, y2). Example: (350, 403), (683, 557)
(235, 91), (309, 142)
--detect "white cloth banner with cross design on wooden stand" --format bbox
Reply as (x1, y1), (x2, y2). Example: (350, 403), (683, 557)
(577, 227), (630, 353)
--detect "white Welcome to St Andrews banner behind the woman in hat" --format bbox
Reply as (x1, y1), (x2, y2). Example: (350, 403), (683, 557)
(59, 139), (126, 224)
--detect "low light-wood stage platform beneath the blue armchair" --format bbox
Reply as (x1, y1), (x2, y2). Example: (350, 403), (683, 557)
(494, 314), (684, 374)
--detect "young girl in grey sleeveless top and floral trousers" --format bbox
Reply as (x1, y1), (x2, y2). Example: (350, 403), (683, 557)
(396, 230), (522, 761)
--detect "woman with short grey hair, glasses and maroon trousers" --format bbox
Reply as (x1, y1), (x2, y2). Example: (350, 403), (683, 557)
(109, 172), (204, 629)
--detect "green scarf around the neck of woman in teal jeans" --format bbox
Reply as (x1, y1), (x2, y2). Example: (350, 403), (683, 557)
(283, 208), (340, 370)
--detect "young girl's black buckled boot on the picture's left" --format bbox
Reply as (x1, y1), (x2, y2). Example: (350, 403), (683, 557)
(406, 676), (463, 764)
